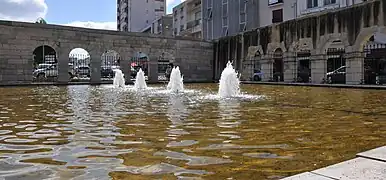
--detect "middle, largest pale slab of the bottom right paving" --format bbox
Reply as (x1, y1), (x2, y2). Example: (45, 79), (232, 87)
(312, 157), (386, 180)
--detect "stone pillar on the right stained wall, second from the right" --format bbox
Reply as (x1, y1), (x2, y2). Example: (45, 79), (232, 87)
(310, 54), (327, 84)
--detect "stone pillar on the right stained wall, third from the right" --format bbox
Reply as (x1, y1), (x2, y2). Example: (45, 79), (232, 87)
(283, 52), (297, 82)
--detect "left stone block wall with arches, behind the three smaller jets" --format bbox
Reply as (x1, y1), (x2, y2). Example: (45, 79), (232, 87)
(0, 21), (213, 84)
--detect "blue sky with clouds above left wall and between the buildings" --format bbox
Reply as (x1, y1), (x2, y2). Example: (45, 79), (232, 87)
(0, 0), (184, 30)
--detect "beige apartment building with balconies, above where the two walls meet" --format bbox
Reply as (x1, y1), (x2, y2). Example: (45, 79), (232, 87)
(173, 0), (202, 38)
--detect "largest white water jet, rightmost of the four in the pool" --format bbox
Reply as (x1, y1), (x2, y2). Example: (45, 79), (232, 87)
(218, 61), (240, 98)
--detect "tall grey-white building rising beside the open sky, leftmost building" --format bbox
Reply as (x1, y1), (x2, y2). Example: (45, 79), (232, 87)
(117, 0), (166, 32)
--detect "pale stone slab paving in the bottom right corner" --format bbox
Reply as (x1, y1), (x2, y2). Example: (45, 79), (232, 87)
(282, 146), (386, 180)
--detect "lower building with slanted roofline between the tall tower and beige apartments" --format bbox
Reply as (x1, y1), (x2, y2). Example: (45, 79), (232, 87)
(141, 14), (173, 36)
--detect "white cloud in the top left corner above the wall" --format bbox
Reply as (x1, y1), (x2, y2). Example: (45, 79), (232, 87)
(0, 0), (48, 22)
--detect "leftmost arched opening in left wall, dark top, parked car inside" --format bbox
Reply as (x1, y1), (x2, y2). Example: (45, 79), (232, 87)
(32, 45), (58, 82)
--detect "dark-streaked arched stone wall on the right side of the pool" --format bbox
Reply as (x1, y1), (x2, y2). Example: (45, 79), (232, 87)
(214, 0), (386, 84)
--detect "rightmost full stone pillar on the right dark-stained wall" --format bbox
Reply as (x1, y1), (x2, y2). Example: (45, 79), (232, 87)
(345, 52), (365, 84)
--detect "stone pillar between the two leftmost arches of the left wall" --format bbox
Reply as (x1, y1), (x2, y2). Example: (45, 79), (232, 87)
(57, 49), (69, 84)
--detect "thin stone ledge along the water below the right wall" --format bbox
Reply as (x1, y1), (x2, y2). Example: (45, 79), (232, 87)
(241, 81), (386, 90)
